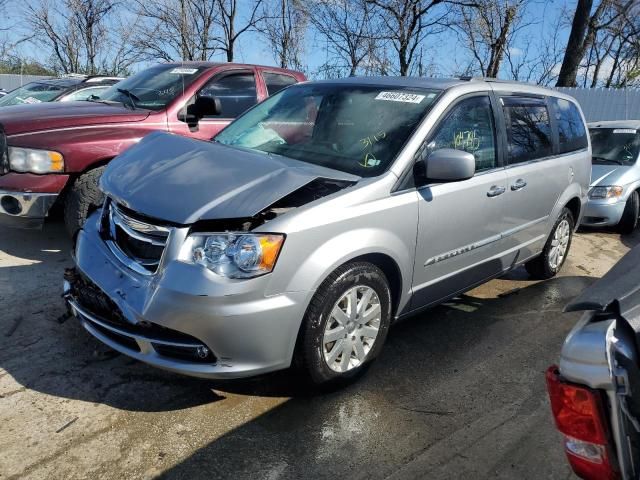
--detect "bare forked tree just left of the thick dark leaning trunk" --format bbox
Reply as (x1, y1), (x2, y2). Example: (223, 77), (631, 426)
(455, 0), (529, 78)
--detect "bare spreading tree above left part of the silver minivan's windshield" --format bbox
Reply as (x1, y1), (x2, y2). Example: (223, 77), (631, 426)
(306, 0), (379, 76)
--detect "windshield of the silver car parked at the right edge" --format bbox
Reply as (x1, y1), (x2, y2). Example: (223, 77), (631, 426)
(589, 128), (640, 166)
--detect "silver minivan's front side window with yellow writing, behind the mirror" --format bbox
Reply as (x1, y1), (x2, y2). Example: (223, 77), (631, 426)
(427, 96), (498, 172)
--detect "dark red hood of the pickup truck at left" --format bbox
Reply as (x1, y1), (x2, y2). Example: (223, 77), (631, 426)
(0, 102), (151, 136)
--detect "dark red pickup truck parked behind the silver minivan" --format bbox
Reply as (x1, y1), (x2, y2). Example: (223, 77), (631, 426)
(0, 62), (305, 234)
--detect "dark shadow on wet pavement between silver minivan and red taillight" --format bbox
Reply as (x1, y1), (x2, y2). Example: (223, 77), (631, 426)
(155, 277), (594, 479)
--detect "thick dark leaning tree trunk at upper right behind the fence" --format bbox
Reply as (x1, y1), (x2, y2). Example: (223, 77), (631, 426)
(556, 0), (637, 87)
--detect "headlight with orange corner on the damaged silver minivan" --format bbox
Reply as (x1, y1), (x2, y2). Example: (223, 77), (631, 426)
(182, 233), (284, 278)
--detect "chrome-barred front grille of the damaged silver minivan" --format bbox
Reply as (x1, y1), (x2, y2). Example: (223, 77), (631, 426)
(102, 199), (171, 275)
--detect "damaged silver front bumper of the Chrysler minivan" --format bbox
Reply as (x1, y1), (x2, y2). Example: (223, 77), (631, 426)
(65, 212), (309, 378)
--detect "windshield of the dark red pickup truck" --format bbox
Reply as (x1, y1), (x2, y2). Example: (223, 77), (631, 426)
(100, 65), (209, 110)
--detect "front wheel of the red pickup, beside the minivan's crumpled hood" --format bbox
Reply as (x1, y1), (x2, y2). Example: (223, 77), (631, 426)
(64, 167), (106, 237)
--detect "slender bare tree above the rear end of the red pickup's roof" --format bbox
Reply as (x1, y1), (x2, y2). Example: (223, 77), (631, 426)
(261, 0), (307, 70)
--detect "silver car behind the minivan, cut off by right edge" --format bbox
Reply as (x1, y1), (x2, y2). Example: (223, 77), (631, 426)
(582, 120), (640, 233)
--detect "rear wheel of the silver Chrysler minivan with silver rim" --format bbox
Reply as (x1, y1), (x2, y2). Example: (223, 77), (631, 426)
(525, 207), (575, 280)
